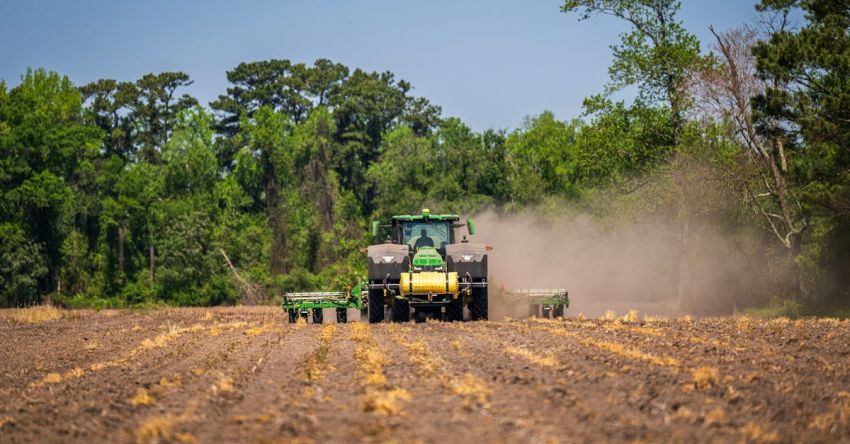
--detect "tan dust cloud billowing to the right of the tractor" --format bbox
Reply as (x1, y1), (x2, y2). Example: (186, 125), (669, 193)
(473, 211), (762, 319)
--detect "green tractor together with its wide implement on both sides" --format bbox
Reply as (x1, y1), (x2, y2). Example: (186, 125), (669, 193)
(282, 209), (569, 323)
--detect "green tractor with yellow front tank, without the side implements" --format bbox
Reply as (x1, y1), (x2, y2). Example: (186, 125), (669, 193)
(366, 209), (490, 323)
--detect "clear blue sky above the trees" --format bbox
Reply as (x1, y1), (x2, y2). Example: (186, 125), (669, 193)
(0, 0), (756, 131)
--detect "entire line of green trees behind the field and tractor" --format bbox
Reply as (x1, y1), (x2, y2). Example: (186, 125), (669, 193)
(0, 0), (850, 312)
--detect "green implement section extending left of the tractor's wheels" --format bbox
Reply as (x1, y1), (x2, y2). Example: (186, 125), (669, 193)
(281, 285), (365, 324)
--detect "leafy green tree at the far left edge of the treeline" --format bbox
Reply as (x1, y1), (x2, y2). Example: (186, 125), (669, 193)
(0, 70), (101, 300)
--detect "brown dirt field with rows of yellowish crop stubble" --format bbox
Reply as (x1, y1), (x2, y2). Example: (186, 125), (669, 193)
(0, 308), (850, 442)
